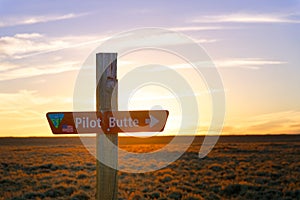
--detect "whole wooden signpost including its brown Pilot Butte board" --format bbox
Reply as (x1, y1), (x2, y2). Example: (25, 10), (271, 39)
(46, 53), (169, 200)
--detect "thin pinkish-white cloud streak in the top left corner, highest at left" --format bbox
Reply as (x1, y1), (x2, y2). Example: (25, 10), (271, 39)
(0, 13), (87, 28)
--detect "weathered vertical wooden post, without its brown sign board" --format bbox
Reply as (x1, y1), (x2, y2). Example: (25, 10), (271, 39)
(96, 53), (118, 200)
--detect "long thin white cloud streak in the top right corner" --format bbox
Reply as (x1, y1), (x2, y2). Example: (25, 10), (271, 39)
(192, 13), (300, 23)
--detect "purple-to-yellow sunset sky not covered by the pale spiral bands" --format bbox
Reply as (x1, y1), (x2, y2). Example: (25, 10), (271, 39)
(0, 0), (300, 137)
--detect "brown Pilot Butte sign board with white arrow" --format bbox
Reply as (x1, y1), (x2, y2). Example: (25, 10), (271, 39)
(46, 110), (169, 134)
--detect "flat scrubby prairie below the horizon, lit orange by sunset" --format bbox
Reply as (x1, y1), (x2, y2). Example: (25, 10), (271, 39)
(0, 135), (300, 200)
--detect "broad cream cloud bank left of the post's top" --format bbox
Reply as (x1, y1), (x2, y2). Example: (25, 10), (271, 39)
(0, 33), (108, 81)
